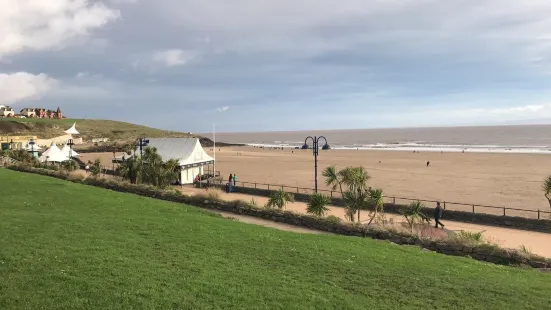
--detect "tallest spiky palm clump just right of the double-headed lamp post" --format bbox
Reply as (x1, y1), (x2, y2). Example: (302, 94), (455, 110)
(322, 166), (370, 222)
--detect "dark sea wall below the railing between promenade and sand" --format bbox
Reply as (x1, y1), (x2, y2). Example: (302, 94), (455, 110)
(222, 186), (551, 233)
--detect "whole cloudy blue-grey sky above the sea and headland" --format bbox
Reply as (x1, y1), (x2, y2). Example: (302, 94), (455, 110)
(0, 0), (551, 132)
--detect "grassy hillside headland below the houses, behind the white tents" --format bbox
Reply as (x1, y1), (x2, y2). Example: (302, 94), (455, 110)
(0, 118), (194, 140)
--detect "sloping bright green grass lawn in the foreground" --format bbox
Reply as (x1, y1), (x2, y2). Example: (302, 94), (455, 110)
(0, 169), (551, 309)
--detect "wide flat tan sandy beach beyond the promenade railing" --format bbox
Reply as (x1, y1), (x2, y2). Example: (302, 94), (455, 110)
(207, 147), (551, 218)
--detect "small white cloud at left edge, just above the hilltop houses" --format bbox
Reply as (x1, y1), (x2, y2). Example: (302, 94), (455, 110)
(0, 72), (58, 105)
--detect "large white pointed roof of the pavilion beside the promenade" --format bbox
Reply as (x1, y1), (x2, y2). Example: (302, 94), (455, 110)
(136, 138), (214, 167)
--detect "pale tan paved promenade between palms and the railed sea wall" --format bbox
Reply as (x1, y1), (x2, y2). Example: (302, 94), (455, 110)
(180, 187), (551, 257)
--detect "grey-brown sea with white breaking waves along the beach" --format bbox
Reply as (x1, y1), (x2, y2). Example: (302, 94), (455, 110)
(212, 125), (551, 154)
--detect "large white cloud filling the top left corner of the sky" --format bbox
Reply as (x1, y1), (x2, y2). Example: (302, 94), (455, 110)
(0, 0), (119, 56)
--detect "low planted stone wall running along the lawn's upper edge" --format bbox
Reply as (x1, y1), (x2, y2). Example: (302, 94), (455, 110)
(9, 166), (551, 270)
